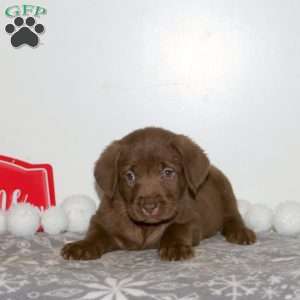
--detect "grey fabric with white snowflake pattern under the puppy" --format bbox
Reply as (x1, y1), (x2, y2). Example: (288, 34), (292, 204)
(0, 233), (300, 300)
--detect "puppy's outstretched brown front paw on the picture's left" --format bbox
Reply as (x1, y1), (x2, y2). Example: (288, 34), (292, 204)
(61, 240), (104, 260)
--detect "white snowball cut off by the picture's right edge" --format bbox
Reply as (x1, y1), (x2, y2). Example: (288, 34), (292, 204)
(273, 202), (300, 235)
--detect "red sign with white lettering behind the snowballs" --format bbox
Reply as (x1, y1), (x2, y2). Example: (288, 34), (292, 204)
(0, 155), (55, 210)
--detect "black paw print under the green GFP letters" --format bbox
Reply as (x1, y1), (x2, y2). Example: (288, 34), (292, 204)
(5, 17), (45, 47)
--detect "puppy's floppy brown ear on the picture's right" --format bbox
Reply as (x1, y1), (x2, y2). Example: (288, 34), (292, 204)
(171, 135), (210, 194)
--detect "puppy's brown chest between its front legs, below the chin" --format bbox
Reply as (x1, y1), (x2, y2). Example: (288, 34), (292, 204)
(115, 225), (167, 250)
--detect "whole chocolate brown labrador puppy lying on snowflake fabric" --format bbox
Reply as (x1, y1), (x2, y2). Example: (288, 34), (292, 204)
(62, 127), (256, 260)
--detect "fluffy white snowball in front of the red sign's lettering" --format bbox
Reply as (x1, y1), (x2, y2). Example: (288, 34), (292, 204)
(7, 203), (40, 237)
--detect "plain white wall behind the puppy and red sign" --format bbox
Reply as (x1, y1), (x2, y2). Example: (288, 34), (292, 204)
(0, 0), (300, 207)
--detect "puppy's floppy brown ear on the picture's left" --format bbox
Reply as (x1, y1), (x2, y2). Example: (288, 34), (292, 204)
(94, 141), (121, 198)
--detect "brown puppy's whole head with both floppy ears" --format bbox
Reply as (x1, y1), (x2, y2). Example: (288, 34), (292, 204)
(94, 128), (209, 224)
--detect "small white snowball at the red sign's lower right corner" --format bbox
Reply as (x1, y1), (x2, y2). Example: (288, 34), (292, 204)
(41, 206), (68, 234)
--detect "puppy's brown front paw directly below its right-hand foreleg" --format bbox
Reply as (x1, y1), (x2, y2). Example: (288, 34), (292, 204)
(159, 244), (194, 261)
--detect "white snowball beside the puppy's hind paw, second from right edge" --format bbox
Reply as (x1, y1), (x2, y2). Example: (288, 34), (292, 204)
(244, 204), (272, 232)
